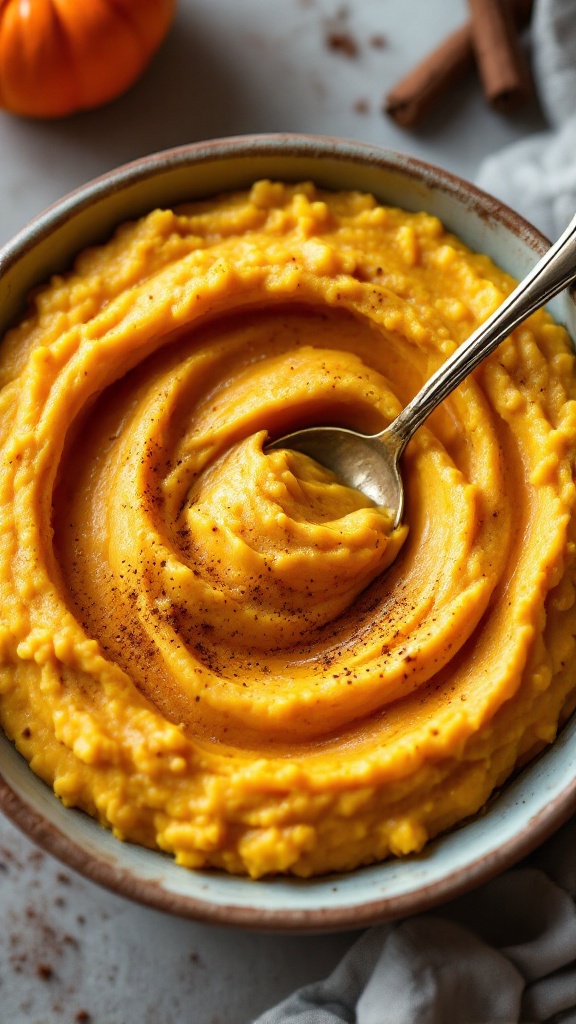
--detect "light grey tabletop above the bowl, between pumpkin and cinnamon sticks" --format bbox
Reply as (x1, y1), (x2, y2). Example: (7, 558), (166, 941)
(0, 0), (542, 244)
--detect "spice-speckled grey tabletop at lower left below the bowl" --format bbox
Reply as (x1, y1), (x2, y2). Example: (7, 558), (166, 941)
(0, 820), (349, 1024)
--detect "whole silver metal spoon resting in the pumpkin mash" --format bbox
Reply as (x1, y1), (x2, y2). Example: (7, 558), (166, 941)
(266, 211), (576, 526)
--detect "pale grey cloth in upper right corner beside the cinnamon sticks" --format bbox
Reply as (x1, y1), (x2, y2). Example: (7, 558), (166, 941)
(478, 0), (576, 241)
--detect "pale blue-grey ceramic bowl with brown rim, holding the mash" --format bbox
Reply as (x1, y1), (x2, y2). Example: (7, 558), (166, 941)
(0, 135), (576, 931)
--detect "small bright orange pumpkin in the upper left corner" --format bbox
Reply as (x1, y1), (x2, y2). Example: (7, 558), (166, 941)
(0, 0), (176, 118)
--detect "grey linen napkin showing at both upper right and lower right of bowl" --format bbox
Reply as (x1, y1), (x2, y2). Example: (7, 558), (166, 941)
(255, 0), (576, 1024)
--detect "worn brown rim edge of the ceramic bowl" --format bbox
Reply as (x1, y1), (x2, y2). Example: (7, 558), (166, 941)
(0, 133), (576, 932)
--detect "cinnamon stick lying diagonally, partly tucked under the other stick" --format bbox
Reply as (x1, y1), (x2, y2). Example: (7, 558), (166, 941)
(384, 0), (532, 127)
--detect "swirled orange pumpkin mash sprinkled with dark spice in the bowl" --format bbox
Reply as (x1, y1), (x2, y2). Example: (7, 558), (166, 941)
(0, 181), (576, 877)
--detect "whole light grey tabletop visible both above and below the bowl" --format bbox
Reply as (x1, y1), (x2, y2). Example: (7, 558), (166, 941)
(0, 0), (542, 1024)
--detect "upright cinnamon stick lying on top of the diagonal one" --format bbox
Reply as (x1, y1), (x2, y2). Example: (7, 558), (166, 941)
(468, 0), (531, 110)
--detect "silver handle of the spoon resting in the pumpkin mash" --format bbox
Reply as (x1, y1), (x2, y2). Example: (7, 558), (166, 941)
(393, 217), (576, 455)
